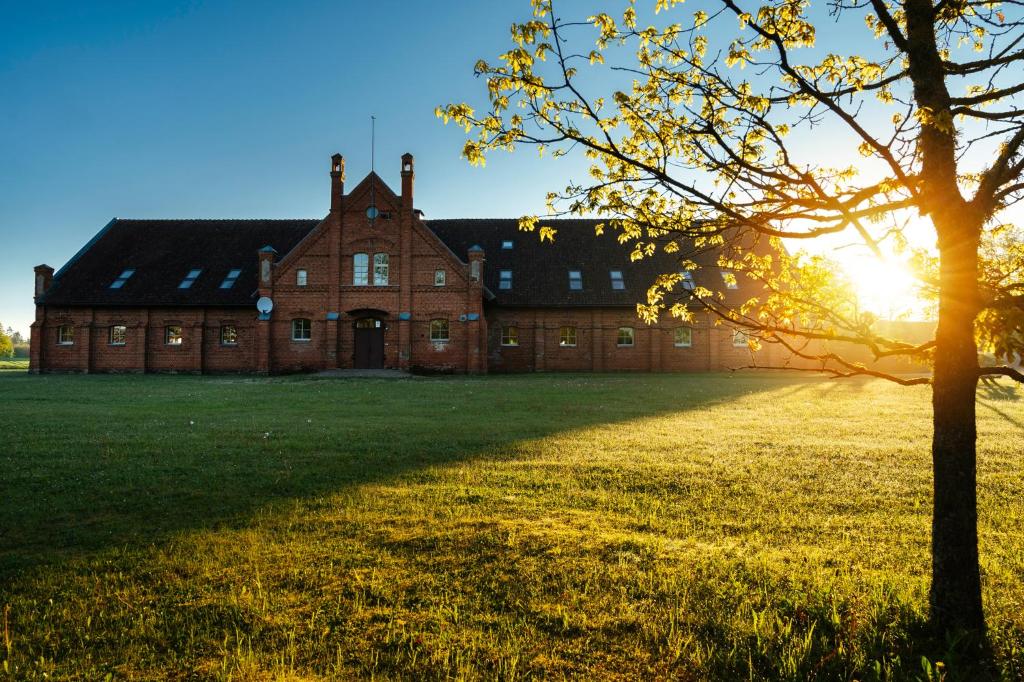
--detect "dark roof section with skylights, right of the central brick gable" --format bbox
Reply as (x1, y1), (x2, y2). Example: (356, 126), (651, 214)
(426, 218), (751, 306)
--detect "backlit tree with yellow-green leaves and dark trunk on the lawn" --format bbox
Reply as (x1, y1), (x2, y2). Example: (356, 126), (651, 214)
(437, 0), (1024, 636)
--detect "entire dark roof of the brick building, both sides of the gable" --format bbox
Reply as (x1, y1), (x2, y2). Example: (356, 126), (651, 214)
(41, 218), (751, 307)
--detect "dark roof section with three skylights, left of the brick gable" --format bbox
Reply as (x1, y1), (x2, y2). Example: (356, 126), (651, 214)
(42, 219), (319, 306)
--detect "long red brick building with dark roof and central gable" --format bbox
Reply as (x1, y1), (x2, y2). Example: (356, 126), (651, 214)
(31, 155), (770, 374)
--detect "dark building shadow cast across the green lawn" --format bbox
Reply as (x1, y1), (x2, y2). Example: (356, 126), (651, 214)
(0, 375), (778, 579)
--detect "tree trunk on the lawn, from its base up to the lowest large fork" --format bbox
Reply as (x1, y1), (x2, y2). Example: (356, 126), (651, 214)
(930, 224), (985, 637)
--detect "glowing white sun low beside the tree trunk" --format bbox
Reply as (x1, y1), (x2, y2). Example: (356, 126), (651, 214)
(840, 254), (925, 319)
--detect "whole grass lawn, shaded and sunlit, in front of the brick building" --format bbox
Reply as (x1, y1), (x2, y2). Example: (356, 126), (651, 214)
(0, 372), (1024, 680)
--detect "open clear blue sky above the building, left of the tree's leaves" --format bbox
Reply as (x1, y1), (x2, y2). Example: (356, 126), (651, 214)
(0, 0), (598, 332)
